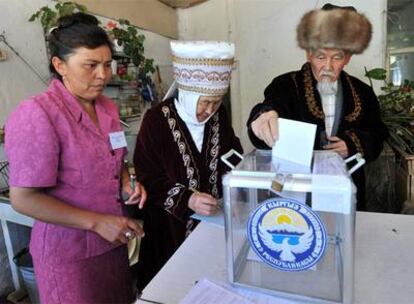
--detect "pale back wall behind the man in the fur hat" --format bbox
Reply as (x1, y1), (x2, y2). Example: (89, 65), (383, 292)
(178, 0), (386, 151)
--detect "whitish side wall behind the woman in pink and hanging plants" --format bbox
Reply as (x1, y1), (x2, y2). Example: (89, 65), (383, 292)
(0, 0), (172, 125)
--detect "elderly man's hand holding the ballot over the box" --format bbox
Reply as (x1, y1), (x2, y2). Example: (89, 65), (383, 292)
(252, 111), (279, 148)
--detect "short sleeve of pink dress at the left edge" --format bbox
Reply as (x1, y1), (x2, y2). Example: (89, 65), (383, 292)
(5, 100), (59, 187)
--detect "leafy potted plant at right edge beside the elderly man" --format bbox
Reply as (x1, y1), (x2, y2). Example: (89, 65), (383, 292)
(365, 68), (414, 213)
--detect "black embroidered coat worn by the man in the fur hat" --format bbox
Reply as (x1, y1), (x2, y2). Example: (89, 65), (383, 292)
(247, 63), (388, 210)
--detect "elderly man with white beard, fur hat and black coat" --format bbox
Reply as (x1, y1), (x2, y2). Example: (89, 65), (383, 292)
(247, 4), (387, 210)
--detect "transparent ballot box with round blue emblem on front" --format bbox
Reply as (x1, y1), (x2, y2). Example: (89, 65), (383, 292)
(223, 150), (356, 303)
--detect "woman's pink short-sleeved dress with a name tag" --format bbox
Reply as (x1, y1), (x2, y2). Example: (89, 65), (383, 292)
(5, 80), (131, 304)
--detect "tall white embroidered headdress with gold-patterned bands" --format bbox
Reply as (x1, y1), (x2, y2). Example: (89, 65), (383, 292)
(171, 41), (234, 96)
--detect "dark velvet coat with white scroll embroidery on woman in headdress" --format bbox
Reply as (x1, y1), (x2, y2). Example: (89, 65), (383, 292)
(134, 98), (243, 288)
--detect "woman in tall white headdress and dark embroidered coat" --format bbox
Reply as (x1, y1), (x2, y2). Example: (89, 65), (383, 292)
(134, 41), (243, 289)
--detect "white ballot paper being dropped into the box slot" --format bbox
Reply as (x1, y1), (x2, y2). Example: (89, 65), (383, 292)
(272, 118), (316, 167)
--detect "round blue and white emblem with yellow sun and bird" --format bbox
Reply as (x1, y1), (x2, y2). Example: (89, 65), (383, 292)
(247, 197), (327, 271)
